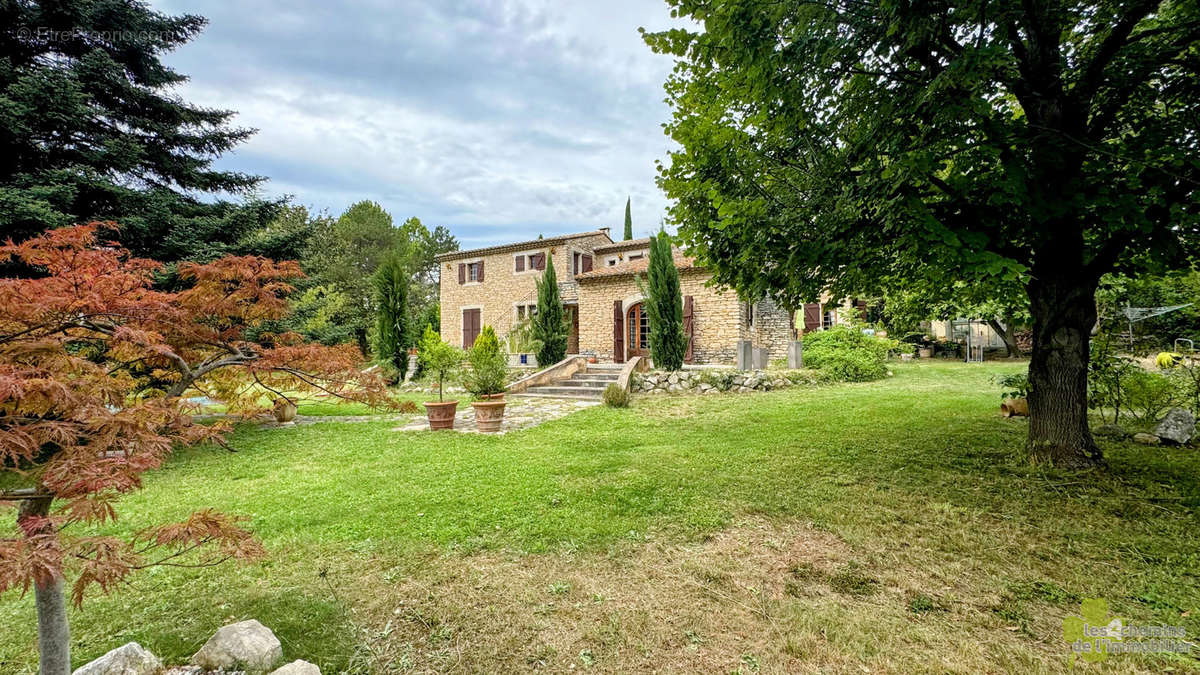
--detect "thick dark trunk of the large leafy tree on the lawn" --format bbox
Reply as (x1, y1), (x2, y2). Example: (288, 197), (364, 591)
(1028, 275), (1103, 468)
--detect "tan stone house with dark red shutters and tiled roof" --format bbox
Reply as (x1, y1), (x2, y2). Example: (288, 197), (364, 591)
(437, 228), (796, 364)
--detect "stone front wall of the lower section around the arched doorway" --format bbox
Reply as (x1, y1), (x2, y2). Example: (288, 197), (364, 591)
(580, 268), (744, 364)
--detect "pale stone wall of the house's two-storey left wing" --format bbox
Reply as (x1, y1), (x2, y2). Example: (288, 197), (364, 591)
(439, 234), (612, 347)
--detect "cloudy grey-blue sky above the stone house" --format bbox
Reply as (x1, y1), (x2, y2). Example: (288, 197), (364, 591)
(152, 0), (686, 247)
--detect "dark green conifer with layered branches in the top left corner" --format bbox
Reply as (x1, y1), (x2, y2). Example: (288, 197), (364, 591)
(0, 0), (277, 262)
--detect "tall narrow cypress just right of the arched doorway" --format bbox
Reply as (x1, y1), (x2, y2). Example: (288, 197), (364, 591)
(638, 232), (688, 370)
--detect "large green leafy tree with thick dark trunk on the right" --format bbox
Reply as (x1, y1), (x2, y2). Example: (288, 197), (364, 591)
(647, 0), (1200, 466)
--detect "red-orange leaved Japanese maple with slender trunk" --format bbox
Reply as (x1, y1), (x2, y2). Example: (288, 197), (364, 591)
(0, 223), (390, 674)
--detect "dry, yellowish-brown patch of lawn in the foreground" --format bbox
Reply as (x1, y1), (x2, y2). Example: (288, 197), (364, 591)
(338, 518), (1171, 673)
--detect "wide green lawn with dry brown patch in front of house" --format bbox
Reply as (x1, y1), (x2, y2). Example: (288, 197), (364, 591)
(0, 363), (1200, 673)
